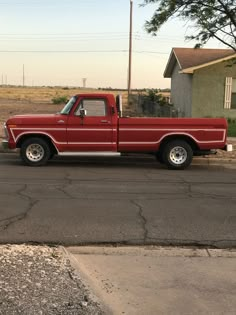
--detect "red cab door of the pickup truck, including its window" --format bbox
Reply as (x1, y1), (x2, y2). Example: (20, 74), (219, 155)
(67, 97), (116, 152)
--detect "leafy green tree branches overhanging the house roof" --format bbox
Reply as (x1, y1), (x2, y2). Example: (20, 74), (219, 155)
(143, 0), (236, 51)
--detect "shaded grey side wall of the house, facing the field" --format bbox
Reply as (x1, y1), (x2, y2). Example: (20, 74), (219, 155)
(171, 63), (192, 117)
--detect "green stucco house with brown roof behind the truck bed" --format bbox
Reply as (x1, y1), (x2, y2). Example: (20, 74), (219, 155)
(164, 48), (236, 118)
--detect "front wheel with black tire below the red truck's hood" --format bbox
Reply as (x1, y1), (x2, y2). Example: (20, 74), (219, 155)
(20, 137), (51, 166)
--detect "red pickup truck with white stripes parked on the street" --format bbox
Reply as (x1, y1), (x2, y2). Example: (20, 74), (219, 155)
(3, 94), (227, 169)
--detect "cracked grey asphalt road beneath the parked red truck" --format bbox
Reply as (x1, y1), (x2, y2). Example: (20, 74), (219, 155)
(0, 154), (236, 248)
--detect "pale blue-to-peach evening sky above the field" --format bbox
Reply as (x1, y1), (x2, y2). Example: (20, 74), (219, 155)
(0, 0), (225, 89)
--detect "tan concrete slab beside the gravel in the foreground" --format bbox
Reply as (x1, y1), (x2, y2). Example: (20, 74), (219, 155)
(67, 246), (236, 315)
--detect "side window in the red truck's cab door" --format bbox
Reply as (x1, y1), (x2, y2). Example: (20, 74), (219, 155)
(75, 99), (106, 116)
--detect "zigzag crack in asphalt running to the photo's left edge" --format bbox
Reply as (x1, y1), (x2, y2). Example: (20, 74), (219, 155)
(0, 184), (38, 231)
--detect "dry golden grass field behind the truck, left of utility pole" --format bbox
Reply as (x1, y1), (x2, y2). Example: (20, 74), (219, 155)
(0, 87), (127, 138)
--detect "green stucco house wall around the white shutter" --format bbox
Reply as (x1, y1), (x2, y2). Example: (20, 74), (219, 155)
(192, 62), (236, 118)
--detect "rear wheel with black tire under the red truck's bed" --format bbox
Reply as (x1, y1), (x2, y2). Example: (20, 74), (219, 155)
(162, 140), (193, 170)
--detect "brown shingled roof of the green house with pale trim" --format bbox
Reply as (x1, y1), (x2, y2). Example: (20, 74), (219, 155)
(164, 48), (236, 78)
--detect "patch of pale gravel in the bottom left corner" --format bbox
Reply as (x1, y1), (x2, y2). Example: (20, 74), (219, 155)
(0, 245), (104, 315)
